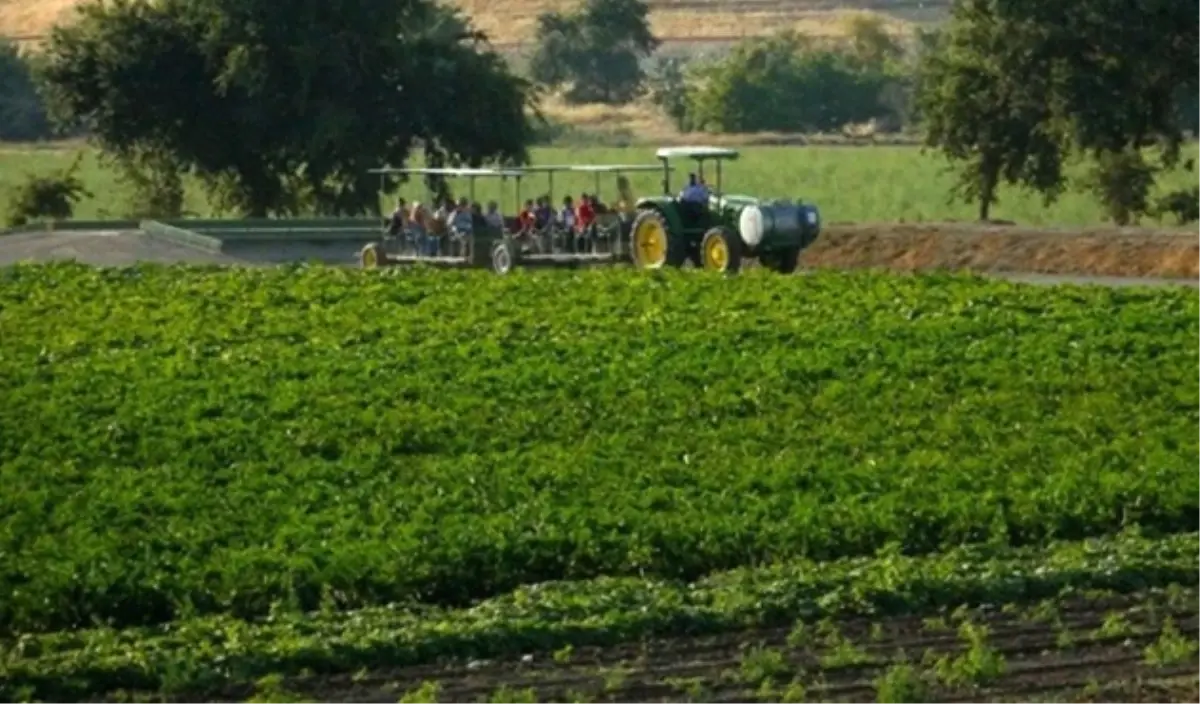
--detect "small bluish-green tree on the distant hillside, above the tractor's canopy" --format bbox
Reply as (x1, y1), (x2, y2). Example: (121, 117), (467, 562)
(529, 0), (659, 104)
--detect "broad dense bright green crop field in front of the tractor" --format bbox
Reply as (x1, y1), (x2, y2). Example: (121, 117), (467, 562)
(0, 265), (1200, 632)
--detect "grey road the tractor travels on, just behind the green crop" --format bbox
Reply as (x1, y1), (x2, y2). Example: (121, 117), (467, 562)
(0, 230), (1200, 288)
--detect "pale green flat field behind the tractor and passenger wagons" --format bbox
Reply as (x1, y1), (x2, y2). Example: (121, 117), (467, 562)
(7, 146), (1193, 225)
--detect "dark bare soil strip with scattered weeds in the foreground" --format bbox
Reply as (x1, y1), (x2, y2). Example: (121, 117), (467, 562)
(177, 595), (1200, 703)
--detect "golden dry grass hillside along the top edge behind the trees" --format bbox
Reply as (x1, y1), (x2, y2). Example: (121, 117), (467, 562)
(0, 0), (948, 44)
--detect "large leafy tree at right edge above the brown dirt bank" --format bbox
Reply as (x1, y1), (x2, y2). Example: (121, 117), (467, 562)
(918, 0), (1200, 219)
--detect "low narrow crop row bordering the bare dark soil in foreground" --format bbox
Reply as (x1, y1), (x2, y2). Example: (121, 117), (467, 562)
(7, 534), (1200, 698)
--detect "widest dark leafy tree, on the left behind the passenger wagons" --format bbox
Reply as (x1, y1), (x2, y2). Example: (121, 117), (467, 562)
(42, 0), (533, 216)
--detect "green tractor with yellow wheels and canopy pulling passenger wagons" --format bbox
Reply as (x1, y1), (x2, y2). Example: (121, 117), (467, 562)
(629, 146), (821, 273)
